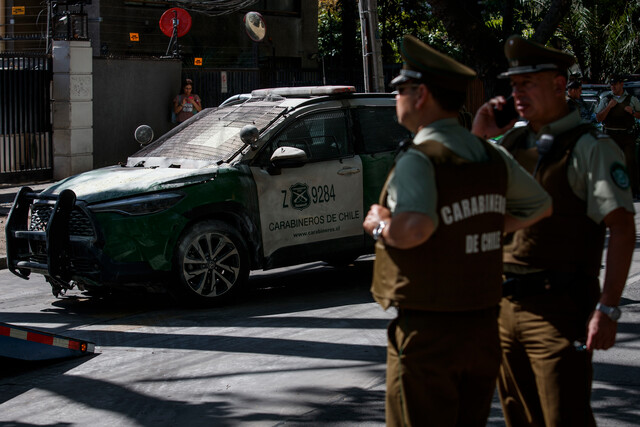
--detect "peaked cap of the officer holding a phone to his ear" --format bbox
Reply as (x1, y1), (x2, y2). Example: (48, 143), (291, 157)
(498, 35), (576, 78)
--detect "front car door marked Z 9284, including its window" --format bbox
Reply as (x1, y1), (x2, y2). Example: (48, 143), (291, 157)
(251, 109), (363, 264)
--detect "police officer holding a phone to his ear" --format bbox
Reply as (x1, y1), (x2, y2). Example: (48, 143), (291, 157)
(472, 36), (635, 426)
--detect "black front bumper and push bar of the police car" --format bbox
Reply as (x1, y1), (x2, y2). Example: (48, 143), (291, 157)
(6, 187), (161, 297)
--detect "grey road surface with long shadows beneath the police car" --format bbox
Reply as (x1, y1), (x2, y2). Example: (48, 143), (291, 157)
(0, 237), (640, 427)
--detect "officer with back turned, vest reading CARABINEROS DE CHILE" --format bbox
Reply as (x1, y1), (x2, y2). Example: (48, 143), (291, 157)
(363, 36), (550, 426)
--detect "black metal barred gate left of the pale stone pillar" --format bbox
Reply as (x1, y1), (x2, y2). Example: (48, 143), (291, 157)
(0, 53), (53, 183)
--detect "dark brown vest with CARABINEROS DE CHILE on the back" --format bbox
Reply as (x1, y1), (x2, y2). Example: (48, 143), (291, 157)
(371, 141), (507, 311)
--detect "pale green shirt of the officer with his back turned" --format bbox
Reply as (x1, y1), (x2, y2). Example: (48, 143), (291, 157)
(387, 118), (551, 228)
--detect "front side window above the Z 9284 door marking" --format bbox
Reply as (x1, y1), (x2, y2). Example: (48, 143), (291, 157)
(265, 110), (351, 162)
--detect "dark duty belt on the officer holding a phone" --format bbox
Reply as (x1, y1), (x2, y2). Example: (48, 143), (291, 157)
(502, 271), (576, 299)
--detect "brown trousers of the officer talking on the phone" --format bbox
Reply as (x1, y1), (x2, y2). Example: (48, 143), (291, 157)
(498, 293), (595, 427)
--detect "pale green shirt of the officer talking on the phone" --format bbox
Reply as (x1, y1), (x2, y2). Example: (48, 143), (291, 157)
(504, 111), (635, 224)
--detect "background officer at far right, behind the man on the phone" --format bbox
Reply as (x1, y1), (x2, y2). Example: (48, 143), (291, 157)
(596, 75), (640, 196)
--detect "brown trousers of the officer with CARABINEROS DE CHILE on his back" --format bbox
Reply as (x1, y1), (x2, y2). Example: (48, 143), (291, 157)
(386, 308), (500, 427)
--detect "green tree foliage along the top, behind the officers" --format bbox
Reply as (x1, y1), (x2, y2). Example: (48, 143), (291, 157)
(318, 0), (640, 81)
